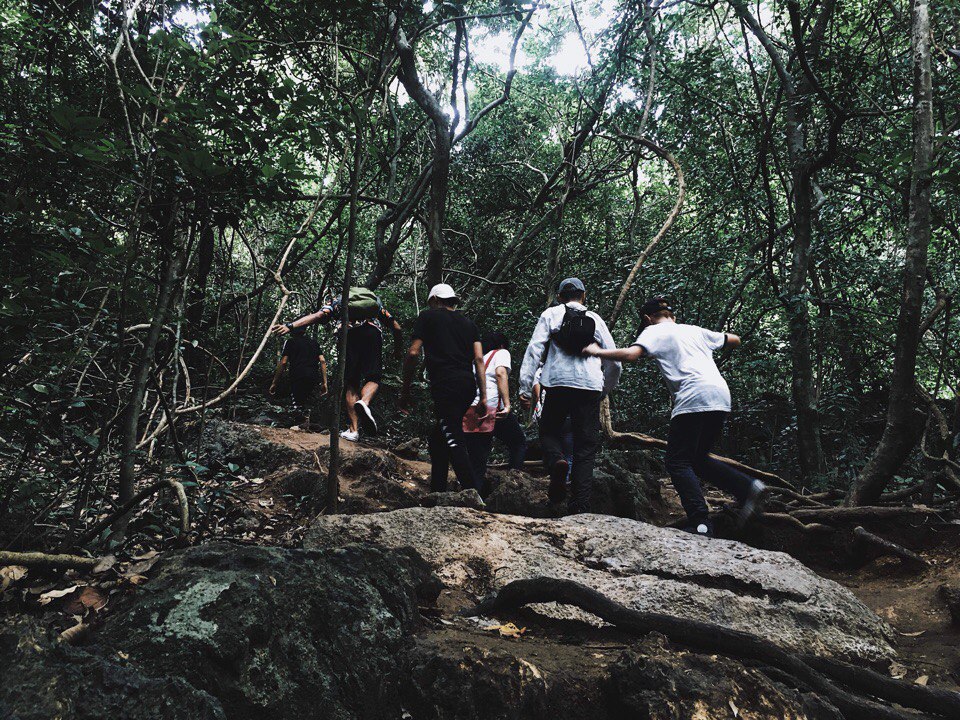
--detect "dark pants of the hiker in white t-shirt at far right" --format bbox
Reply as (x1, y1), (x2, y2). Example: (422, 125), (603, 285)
(666, 411), (753, 525)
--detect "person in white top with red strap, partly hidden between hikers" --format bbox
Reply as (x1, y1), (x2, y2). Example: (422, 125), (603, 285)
(464, 332), (527, 495)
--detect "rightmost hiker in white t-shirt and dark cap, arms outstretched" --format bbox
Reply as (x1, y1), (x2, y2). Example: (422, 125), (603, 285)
(584, 297), (766, 536)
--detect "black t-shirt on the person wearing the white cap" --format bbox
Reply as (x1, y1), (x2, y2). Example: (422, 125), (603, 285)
(413, 308), (480, 387)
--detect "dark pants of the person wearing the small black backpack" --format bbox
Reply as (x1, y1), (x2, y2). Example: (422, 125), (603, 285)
(540, 387), (602, 513)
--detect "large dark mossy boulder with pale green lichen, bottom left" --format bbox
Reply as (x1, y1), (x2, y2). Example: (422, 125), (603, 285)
(97, 542), (439, 720)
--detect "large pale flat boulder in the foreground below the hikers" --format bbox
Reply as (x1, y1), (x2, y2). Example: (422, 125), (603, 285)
(304, 507), (895, 664)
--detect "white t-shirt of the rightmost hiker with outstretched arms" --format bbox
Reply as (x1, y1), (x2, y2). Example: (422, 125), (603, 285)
(634, 322), (730, 417)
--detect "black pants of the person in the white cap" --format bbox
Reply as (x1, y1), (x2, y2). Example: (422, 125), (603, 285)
(427, 377), (477, 492)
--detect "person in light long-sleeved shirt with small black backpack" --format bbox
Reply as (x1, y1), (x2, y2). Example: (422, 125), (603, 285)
(520, 278), (621, 513)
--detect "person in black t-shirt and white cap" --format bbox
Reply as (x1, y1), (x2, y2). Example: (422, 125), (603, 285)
(400, 283), (487, 492)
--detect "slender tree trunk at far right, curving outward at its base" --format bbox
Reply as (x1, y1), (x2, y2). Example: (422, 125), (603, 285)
(848, 0), (933, 505)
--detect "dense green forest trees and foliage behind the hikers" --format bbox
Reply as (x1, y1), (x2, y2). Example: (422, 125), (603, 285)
(0, 0), (960, 542)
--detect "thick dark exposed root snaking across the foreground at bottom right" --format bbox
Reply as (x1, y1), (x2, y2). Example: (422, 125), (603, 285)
(464, 577), (960, 720)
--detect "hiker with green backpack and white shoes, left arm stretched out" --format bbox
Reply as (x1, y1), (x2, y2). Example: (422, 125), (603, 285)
(273, 287), (403, 442)
